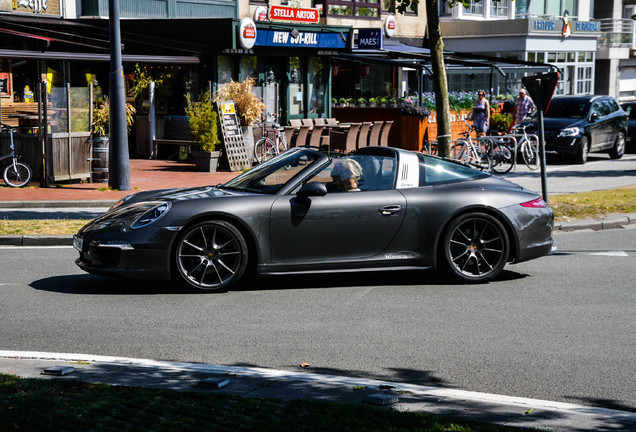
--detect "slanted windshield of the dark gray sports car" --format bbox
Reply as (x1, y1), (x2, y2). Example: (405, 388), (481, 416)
(222, 148), (320, 194)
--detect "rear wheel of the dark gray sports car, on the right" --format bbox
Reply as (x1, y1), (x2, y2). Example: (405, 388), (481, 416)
(443, 213), (510, 283)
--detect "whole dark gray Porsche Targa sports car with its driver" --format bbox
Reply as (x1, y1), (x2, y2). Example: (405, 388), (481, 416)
(74, 147), (554, 291)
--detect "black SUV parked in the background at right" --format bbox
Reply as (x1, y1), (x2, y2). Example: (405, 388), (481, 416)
(524, 96), (627, 164)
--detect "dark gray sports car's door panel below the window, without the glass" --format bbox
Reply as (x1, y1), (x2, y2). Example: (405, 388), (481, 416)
(270, 189), (406, 264)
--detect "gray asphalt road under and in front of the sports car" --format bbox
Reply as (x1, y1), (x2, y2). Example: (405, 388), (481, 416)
(0, 225), (636, 411)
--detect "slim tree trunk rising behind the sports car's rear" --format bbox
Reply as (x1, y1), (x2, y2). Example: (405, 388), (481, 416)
(426, 0), (452, 157)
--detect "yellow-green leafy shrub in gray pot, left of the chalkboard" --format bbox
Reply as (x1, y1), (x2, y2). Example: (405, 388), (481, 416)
(185, 91), (221, 172)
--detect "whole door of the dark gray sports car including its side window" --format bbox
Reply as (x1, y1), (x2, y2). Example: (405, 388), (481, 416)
(270, 155), (406, 263)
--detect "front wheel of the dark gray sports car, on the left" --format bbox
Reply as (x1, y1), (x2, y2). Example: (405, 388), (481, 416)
(174, 220), (248, 291)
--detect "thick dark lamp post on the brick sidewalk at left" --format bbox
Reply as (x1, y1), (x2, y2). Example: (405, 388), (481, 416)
(108, 0), (131, 190)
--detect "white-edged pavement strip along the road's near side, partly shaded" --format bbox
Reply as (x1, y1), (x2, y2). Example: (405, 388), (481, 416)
(0, 351), (636, 432)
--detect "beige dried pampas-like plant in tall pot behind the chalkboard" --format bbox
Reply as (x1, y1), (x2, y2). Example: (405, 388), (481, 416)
(214, 78), (265, 162)
